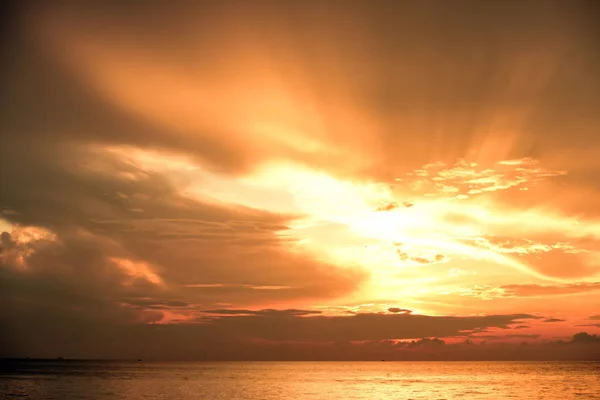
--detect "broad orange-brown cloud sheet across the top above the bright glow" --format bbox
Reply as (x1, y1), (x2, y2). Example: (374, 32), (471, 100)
(11, 3), (594, 181)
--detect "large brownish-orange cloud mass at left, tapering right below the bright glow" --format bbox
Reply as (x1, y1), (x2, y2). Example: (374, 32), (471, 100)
(0, 139), (367, 334)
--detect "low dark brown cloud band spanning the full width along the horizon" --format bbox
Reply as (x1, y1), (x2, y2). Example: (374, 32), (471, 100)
(1, 309), (600, 360)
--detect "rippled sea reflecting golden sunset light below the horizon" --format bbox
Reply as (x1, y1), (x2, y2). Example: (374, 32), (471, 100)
(0, 361), (600, 400)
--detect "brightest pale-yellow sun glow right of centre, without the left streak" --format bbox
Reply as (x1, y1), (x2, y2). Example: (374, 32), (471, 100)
(247, 159), (600, 291)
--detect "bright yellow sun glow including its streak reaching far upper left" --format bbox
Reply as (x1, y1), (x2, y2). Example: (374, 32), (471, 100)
(96, 149), (600, 304)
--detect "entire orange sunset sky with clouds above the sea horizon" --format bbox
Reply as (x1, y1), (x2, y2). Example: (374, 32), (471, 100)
(0, 0), (600, 359)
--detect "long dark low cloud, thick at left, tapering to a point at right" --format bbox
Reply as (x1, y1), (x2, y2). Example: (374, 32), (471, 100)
(0, 298), (533, 359)
